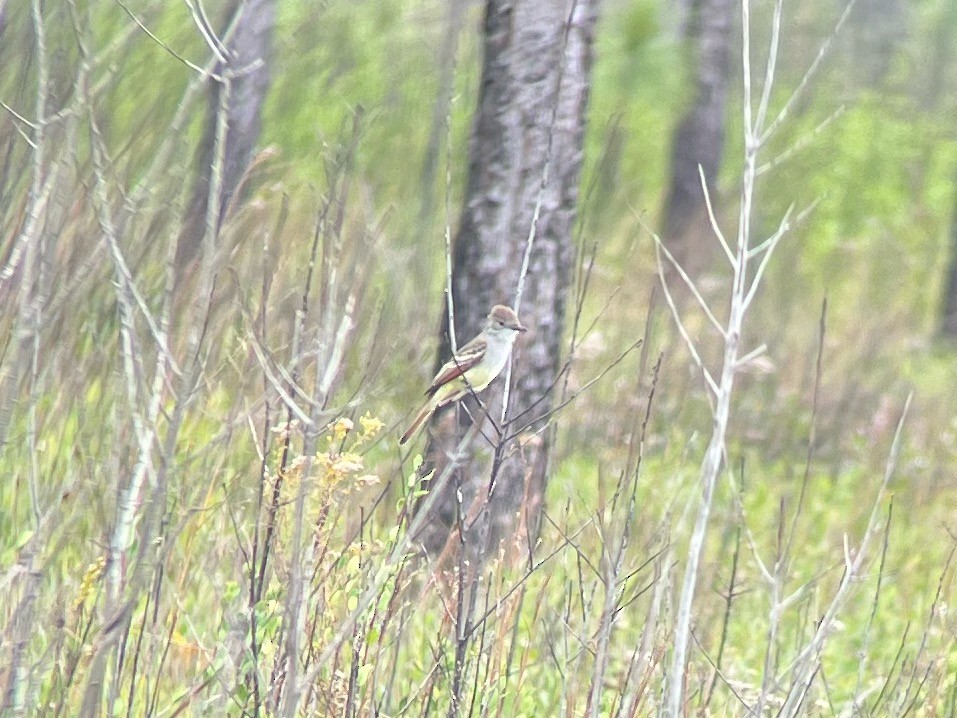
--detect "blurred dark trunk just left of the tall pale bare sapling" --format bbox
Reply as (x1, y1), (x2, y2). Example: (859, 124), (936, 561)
(662, 0), (735, 271)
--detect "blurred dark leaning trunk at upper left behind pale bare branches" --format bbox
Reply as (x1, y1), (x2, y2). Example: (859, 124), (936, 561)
(177, 0), (276, 266)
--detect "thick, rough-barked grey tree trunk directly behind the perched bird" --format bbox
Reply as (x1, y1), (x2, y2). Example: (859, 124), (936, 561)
(422, 0), (598, 555)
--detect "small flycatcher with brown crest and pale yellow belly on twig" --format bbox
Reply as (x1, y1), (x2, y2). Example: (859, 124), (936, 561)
(399, 304), (526, 446)
